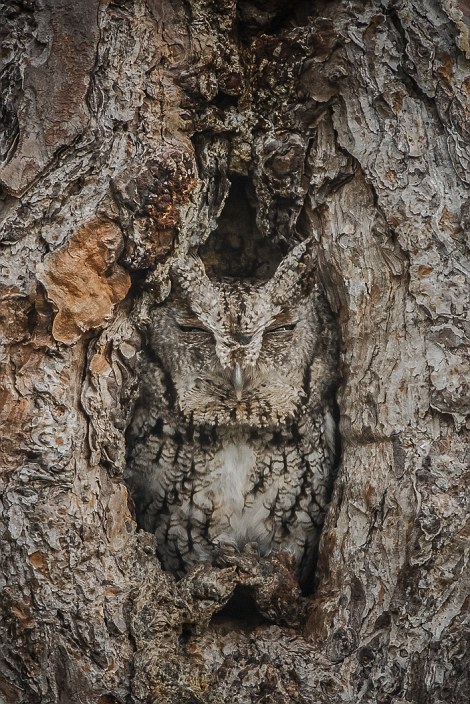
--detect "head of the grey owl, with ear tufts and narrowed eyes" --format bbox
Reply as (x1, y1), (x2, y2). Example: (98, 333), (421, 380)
(150, 243), (318, 428)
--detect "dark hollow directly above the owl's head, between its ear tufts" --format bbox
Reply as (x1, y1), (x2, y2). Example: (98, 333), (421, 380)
(199, 176), (285, 280)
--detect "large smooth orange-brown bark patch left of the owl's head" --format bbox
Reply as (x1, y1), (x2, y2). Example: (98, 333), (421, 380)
(38, 220), (130, 345)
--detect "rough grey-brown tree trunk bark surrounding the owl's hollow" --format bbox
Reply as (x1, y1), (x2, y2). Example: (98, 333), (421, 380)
(0, 0), (470, 704)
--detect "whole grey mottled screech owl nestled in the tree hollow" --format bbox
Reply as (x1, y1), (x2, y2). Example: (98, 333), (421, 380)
(126, 243), (337, 582)
